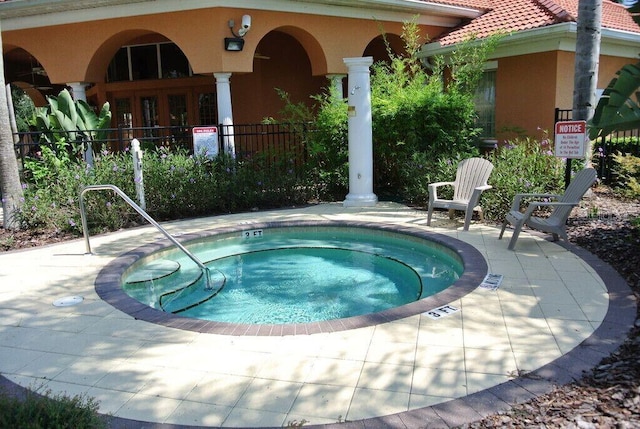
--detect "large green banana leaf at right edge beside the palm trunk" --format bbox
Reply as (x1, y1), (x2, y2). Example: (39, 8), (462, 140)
(589, 63), (640, 140)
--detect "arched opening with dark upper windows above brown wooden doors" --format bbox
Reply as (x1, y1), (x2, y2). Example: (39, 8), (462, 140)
(87, 30), (217, 135)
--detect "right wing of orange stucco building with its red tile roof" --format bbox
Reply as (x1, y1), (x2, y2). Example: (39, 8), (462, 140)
(422, 0), (640, 138)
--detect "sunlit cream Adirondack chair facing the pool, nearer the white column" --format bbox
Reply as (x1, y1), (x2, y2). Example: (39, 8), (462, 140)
(427, 158), (493, 231)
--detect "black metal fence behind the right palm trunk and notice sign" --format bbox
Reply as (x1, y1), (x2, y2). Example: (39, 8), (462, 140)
(554, 109), (640, 183)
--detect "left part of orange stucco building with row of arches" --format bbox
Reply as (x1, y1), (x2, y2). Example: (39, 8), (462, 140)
(0, 0), (479, 127)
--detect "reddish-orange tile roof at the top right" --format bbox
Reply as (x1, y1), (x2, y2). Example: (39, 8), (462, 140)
(432, 0), (640, 46)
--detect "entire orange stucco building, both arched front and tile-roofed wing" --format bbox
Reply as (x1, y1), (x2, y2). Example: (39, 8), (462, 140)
(0, 0), (640, 141)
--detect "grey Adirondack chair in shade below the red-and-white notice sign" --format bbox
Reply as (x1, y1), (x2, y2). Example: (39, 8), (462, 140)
(498, 168), (596, 250)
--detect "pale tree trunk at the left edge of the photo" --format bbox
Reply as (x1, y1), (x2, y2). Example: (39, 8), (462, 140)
(0, 20), (24, 229)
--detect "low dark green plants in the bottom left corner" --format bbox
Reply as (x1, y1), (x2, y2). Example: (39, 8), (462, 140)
(0, 391), (107, 429)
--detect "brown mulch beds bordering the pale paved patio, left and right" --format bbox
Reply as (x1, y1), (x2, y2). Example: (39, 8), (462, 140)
(0, 186), (640, 429)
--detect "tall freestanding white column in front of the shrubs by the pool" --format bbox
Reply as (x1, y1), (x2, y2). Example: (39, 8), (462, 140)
(343, 57), (378, 207)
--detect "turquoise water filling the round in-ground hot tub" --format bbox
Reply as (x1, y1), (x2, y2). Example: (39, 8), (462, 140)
(123, 227), (463, 324)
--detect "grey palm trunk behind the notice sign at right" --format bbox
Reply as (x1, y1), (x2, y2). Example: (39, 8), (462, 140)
(573, 0), (602, 166)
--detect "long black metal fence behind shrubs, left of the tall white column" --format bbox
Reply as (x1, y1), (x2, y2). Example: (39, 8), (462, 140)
(15, 124), (314, 170)
